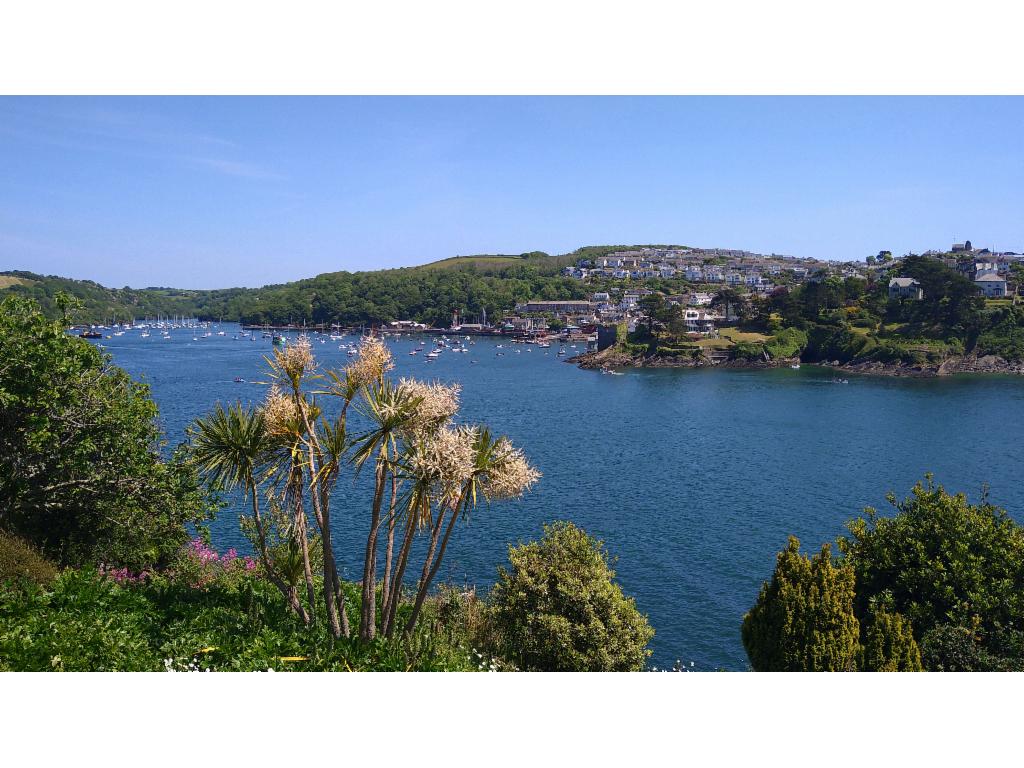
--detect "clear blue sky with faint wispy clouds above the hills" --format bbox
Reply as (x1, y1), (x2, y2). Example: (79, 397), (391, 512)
(0, 97), (1024, 288)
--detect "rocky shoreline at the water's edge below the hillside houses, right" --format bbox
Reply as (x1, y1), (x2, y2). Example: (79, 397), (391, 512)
(565, 347), (1024, 379)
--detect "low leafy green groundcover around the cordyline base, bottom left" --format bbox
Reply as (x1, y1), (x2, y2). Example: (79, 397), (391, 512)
(0, 570), (501, 672)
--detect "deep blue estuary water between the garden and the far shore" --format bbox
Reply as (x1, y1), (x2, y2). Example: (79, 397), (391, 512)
(92, 325), (1024, 670)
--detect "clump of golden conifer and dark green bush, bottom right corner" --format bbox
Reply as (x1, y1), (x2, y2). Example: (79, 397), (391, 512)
(743, 476), (1024, 672)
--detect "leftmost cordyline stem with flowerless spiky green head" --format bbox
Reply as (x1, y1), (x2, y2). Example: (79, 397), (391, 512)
(189, 402), (310, 624)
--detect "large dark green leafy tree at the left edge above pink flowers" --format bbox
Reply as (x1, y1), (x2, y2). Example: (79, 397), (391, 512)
(0, 297), (212, 568)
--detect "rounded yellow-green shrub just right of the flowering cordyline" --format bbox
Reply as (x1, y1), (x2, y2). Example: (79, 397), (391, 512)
(488, 522), (654, 672)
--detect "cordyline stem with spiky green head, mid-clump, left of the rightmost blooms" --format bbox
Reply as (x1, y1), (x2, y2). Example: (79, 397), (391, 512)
(351, 379), (419, 641)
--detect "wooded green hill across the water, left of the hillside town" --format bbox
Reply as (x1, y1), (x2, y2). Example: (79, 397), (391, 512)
(0, 246), (688, 325)
